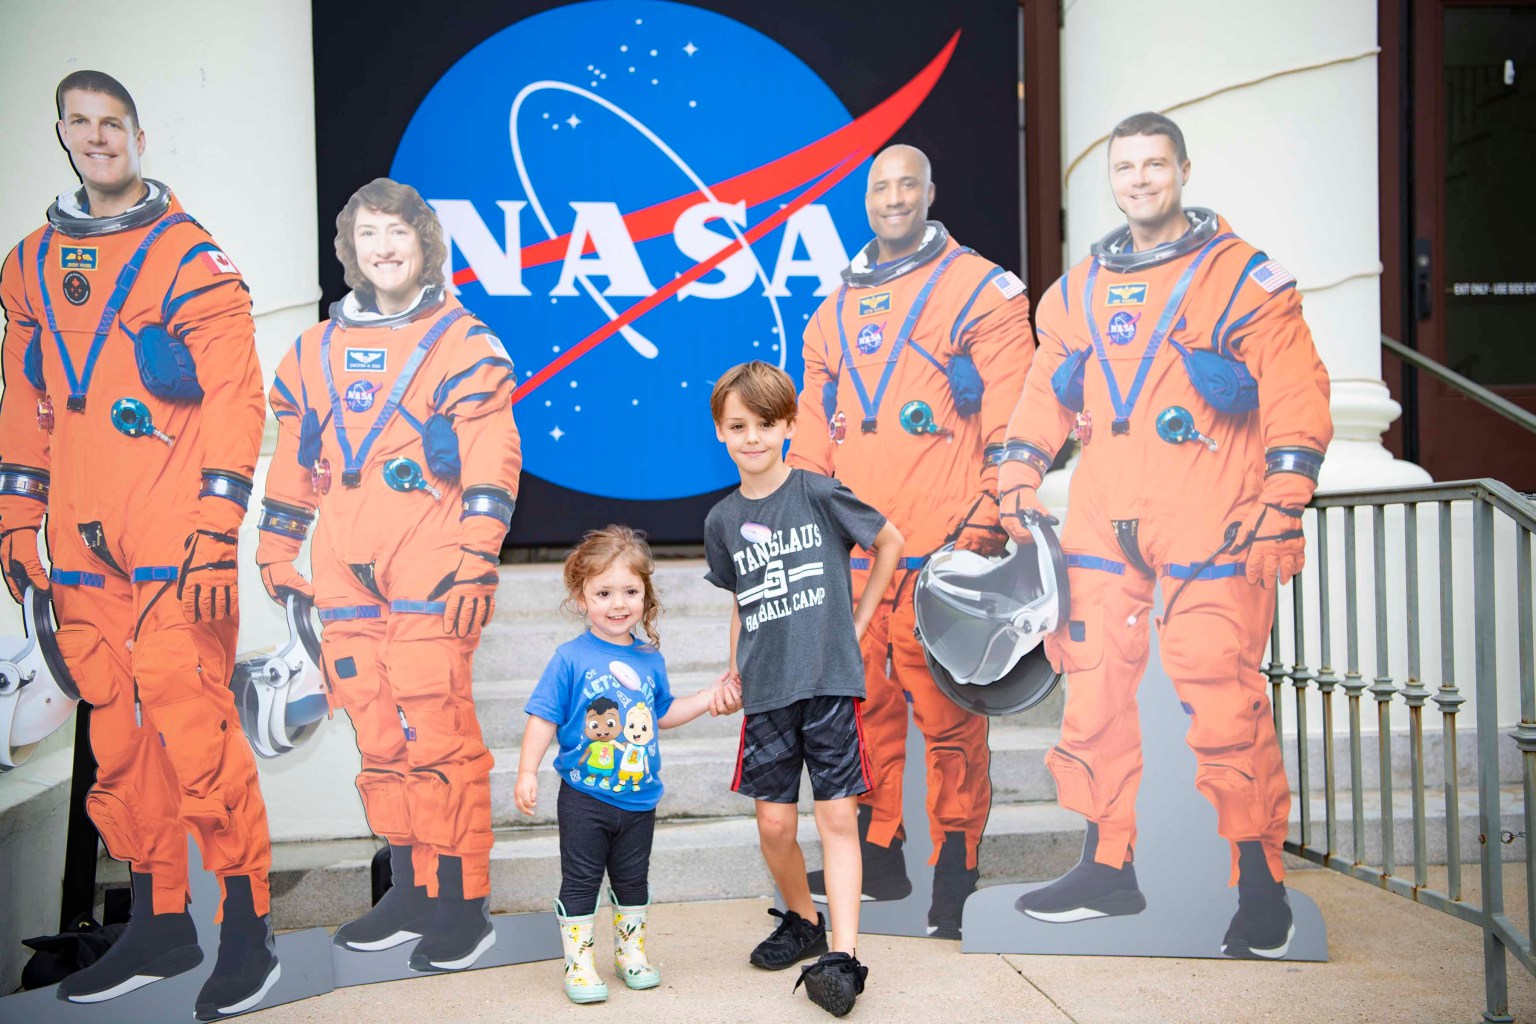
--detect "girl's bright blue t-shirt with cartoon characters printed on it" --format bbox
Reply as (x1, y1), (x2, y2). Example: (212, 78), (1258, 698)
(524, 631), (673, 811)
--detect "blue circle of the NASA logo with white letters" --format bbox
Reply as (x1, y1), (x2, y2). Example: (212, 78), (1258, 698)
(390, 0), (878, 499)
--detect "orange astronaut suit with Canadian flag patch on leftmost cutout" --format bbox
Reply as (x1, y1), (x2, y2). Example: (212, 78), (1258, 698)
(0, 181), (270, 915)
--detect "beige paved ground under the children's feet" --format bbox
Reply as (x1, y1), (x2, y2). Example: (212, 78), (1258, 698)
(244, 869), (1536, 1024)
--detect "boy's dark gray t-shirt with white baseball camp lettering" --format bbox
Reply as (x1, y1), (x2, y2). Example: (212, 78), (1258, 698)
(703, 470), (885, 714)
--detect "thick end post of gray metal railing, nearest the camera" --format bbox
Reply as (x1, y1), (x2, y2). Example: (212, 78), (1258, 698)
(1471, 497), (1514, 1021)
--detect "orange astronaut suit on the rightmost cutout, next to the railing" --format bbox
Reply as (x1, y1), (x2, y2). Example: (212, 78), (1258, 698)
(1000, 209), (1333, 880)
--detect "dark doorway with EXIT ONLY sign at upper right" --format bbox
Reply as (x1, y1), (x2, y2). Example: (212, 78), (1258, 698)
(1381, 0), (1536, 491)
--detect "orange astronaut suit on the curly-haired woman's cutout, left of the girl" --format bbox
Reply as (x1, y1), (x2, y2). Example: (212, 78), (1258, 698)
(257, 289), (522, 900)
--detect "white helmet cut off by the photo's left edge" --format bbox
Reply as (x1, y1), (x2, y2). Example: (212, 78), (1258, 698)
(0, 586), (80, 772)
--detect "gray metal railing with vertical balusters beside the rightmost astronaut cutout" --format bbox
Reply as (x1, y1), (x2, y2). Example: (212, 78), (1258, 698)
(1264, 479), (1536, 1021)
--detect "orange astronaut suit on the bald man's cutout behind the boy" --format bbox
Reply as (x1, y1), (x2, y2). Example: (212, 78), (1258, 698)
(788, 221), (1035, 869)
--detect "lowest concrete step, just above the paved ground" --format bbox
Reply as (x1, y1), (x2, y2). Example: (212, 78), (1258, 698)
(97, 788), (1525, 929)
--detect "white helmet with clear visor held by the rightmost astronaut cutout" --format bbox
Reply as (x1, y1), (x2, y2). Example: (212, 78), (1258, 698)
(912, 517), (1071, 715)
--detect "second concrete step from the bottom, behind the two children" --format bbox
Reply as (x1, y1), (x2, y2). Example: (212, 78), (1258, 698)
(490, 718), (1055, 827)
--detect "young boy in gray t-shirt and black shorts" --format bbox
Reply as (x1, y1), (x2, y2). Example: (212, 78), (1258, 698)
(703, 361), (902, 1016)
